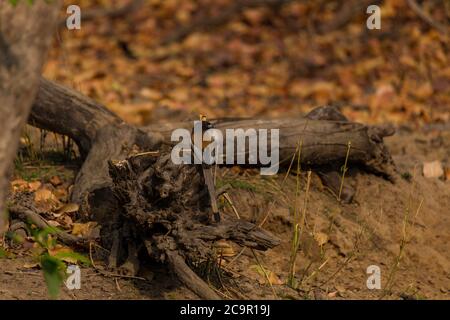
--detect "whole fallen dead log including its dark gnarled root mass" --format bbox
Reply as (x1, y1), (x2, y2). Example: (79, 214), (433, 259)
(29, 79), (395, 298)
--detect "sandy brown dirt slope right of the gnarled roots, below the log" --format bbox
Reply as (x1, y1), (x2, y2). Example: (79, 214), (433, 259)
(212, 126), (450, 299)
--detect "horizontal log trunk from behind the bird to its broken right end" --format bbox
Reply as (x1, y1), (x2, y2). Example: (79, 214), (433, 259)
(143, 115), (394, 178)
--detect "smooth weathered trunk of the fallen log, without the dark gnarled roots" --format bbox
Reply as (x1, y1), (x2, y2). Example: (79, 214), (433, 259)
(29, 79), (395, 206)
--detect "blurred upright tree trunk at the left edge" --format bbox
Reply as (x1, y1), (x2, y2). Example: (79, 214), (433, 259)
(0, 1), (60, 236)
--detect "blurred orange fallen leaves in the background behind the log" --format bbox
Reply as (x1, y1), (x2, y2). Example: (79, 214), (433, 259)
(44, 0), (450, 125)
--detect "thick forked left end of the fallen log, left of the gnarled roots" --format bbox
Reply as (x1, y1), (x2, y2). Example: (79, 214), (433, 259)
(28, 78), (159, 202)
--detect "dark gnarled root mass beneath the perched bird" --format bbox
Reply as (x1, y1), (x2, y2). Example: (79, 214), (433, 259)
(109, 151), (279, 298)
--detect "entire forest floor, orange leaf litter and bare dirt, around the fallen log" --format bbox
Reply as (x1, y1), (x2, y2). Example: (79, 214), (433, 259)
(0, 0), (450, 299)
